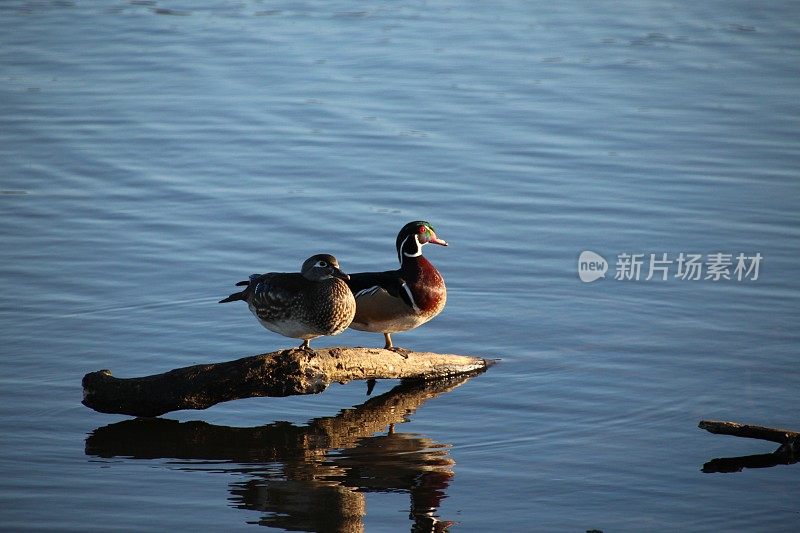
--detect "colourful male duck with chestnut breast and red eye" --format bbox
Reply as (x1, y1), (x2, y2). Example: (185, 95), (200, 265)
(347, 220), (447, 351)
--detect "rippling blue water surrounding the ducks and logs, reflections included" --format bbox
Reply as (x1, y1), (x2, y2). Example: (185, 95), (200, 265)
(0, 0), (800, 532)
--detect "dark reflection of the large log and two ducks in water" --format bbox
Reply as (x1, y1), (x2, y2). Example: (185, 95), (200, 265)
(85, 376), (470, 532)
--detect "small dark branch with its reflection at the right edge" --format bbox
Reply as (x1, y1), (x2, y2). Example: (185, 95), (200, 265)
(698, 420), (800, 473)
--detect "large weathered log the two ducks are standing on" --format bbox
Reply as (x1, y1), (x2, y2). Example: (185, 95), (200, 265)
(82, 347), (494, 417)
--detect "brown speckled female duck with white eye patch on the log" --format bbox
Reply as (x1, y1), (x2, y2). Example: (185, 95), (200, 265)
(219, 254), (356, 350)
